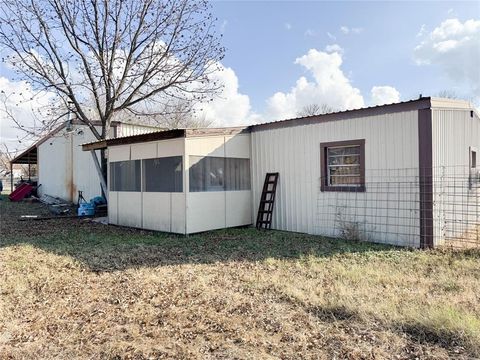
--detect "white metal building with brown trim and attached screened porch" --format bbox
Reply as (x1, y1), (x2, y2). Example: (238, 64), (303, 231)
(83, 97), (480, 247)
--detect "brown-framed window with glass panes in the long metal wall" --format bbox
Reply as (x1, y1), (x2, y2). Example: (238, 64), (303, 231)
(320, 140), (365, 192)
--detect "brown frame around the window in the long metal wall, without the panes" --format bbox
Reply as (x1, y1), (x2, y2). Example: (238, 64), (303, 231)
(320, 139), (365, 192)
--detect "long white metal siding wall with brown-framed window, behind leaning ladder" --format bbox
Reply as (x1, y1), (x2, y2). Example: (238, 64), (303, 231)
(251, 111), (419, 246)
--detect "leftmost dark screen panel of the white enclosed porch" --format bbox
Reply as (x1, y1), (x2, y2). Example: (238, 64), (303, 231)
(110, 160), (141, 191)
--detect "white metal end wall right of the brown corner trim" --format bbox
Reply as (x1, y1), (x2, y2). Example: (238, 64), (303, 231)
(432, 109), (480, 245)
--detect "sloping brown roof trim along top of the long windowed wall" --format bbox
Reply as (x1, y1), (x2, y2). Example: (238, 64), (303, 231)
(251, 97), (431, 132)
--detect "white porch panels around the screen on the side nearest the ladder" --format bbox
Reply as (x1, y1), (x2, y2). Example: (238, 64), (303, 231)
(185, 134), (253, 233)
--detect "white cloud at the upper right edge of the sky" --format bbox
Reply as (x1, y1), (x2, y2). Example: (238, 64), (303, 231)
(414, 19), (480, 99)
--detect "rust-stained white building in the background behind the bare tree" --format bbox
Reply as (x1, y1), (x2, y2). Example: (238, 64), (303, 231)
(11, 120), (161, 202)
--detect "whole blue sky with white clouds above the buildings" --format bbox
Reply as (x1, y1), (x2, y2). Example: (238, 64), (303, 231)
(0, 1), (480, 149)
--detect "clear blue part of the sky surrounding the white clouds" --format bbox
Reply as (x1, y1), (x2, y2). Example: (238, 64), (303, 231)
(213, 1), (480, 112)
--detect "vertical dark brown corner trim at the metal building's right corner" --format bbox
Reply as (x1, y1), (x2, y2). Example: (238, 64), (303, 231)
(418, 109), (434, 249)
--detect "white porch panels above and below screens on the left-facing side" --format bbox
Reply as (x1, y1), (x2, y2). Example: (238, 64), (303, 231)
(108, 138), (186, 234)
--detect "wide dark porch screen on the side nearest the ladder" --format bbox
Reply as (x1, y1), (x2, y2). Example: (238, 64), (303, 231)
(189, 156), (250, 192)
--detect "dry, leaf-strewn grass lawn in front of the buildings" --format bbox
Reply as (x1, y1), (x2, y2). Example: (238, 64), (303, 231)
(0, 197), (480, 359)
